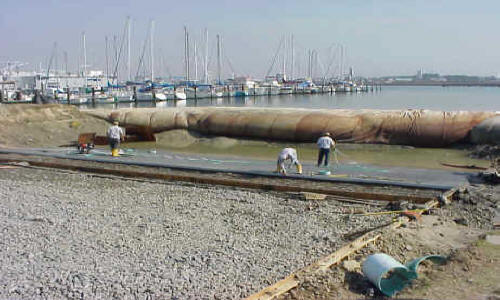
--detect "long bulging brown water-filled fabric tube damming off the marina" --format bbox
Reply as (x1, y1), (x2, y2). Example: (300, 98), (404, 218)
(89, 107), (499, 147)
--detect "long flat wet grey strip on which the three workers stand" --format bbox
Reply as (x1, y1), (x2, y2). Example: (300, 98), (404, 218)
(0, 148), (476, 190)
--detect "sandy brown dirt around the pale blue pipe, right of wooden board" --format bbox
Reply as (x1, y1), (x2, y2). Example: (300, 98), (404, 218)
(279, 186), (500, 300)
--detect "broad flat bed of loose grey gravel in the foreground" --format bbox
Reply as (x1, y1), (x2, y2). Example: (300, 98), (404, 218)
(0, 168), (390, 299)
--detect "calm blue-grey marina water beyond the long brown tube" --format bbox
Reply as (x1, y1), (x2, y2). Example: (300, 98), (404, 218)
(82, 86), (500, 111)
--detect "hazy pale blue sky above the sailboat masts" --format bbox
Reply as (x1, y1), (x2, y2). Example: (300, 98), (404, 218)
(0, 0), (500, 78)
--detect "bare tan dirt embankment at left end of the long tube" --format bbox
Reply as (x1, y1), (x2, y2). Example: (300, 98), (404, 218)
(0, 104), (109, 147)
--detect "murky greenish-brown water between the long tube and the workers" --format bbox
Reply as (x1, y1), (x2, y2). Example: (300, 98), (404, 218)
(124, 139), (489, 172)
